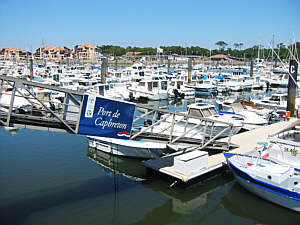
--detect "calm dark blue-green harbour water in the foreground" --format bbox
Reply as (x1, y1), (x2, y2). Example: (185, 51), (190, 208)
(0, 90), (300, 225)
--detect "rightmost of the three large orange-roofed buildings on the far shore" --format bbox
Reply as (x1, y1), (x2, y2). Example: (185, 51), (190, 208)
(73, 44), (102, 61)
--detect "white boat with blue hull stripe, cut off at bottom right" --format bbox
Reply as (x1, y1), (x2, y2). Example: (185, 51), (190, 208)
(224, 153), (300, 212)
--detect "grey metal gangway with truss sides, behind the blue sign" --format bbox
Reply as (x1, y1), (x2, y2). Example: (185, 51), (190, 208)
(0, 75), (233, 150)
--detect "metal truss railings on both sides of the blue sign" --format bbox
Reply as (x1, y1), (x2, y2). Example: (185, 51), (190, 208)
(0, 75), (234, 150)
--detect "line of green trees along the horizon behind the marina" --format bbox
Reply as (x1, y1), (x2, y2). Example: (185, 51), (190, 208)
(98, 41), (300, 59)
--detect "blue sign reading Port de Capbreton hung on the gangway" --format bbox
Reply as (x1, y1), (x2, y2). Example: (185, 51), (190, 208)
(77, 95), (135, 139)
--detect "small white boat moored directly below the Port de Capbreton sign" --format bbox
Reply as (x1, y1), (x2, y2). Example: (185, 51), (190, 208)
(87, 136), (170, 159)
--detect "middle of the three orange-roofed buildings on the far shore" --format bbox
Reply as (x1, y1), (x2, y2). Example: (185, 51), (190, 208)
(34, 46), (71, 61)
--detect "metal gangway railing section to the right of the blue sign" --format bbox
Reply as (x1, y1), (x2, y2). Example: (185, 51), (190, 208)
(130, 104), (234, 150)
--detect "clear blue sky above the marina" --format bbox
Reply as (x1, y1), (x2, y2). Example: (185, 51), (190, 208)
(0, 0), (300, 51)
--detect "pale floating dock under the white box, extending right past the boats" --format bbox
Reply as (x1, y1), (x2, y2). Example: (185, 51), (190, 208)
(144, 119), (296, 182)
